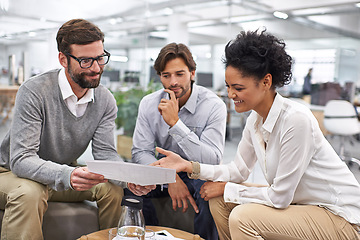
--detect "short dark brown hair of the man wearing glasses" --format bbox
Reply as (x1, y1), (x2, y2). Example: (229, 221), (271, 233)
(56, 19), (104, 53)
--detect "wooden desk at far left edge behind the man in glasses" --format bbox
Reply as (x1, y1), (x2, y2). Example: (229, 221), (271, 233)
(0, 85), (19, 124)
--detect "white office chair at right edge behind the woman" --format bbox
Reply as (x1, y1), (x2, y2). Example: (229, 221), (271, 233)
(324, 100), (360, 167)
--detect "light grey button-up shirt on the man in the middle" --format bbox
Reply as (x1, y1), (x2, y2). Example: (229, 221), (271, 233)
(132, 84), (227, 164)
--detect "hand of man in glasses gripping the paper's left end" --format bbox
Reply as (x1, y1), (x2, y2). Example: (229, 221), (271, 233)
(70, 167), (108, 191)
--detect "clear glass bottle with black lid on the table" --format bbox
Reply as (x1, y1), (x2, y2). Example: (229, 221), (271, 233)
(116, 196), (145, 240)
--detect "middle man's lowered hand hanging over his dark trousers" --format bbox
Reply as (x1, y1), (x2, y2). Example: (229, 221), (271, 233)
(168, 174), (199, 213)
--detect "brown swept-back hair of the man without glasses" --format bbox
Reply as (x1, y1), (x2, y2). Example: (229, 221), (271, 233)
(154, 43), (196, 75)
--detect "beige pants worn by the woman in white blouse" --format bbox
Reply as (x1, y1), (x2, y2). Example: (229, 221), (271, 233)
(209, 197), (360, 240)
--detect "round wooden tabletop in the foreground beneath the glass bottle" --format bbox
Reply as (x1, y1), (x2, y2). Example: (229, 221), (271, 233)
(78, 226), (202, 240)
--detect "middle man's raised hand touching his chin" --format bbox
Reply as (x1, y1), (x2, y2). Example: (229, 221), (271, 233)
(158, 89), (179, 127)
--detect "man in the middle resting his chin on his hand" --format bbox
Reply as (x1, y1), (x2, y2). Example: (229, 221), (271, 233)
(132, 43), (227, 240)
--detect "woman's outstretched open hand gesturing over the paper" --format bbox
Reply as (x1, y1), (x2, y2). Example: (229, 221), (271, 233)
(151, 147), (192, 173)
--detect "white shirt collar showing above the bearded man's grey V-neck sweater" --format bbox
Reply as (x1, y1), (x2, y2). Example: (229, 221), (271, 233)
(59, 69), (94, 117)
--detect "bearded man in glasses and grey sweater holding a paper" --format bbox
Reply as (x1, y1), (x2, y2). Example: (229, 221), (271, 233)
(0, 19), (155, 240)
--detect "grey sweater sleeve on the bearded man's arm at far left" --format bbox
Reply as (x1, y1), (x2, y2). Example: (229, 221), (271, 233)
(9, 85), (74, 191)
